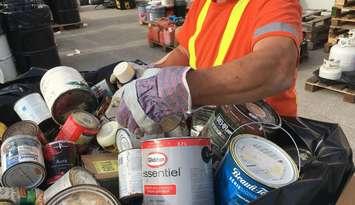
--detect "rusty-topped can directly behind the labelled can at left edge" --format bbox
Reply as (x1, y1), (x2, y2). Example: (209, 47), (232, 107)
(3, 120), (48, 145)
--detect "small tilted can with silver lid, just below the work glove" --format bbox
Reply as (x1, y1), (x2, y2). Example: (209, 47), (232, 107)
(116, 128), (140, 153)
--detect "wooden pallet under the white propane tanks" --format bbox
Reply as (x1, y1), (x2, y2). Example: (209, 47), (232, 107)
(305, 76), (355, 103)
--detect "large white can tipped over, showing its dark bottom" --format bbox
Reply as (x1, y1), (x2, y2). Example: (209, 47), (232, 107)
(40, 66), (98, 124)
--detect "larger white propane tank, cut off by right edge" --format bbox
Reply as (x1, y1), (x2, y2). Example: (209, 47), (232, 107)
(329, 29), (355, 72)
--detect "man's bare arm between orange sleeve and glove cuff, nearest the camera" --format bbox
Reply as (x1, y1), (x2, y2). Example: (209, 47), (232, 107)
(187, 37), (298, 106)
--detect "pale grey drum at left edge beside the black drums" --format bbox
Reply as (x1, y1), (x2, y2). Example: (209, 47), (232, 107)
(0, 34), (17, 83)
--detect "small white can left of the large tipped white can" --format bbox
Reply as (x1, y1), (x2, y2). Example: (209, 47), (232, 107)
(14, 93), (52, 125)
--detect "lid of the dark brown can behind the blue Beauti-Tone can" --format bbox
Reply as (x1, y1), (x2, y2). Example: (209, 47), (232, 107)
(235, 101), (281, 127)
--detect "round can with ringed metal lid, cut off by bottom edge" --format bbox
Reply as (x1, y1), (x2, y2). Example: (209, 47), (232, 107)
(46, 184), (120, 205)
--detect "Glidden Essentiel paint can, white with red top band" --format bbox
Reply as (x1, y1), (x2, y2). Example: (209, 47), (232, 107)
(142, 138), (214, 205)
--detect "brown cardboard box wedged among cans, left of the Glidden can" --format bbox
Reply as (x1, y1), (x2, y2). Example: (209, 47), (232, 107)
(81, 153), (119, 198)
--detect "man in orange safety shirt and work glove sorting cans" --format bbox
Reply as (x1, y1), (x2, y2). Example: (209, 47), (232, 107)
(117, 0), (302, 133)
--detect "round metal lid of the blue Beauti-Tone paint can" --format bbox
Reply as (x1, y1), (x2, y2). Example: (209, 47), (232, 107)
(229, 134), (299, 188)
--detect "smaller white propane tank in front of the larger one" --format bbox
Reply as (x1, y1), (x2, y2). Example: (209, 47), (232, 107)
(319, 59), (342, 80)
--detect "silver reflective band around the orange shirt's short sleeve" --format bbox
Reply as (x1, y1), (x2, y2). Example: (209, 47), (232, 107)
(254, 22), (300, 39)
